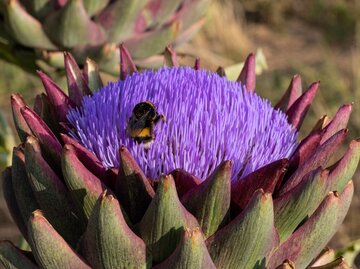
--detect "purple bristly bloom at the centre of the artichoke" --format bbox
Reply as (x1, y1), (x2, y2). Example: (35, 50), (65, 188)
(68, 67), (297, 179)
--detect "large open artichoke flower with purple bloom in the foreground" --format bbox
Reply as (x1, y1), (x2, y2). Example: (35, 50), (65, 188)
(0, 45), (360, 269)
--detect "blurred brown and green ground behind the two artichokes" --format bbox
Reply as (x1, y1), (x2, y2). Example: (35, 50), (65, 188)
(0, 0), (360, 264)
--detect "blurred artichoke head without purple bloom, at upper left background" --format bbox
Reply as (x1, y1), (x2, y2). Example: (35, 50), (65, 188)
(0, 0), (210, 73)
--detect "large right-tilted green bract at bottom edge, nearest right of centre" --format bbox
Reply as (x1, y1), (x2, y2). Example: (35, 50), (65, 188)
(206, 190), (275, 269)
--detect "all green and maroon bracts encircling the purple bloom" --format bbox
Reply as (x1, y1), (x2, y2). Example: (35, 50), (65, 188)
(0, 46), (360, 269)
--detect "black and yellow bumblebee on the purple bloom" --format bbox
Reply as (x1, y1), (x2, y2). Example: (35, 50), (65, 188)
(126, 101), (165, 148)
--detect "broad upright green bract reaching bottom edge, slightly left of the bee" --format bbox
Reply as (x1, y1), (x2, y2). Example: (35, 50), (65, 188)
(81, 192), (151, 269)
